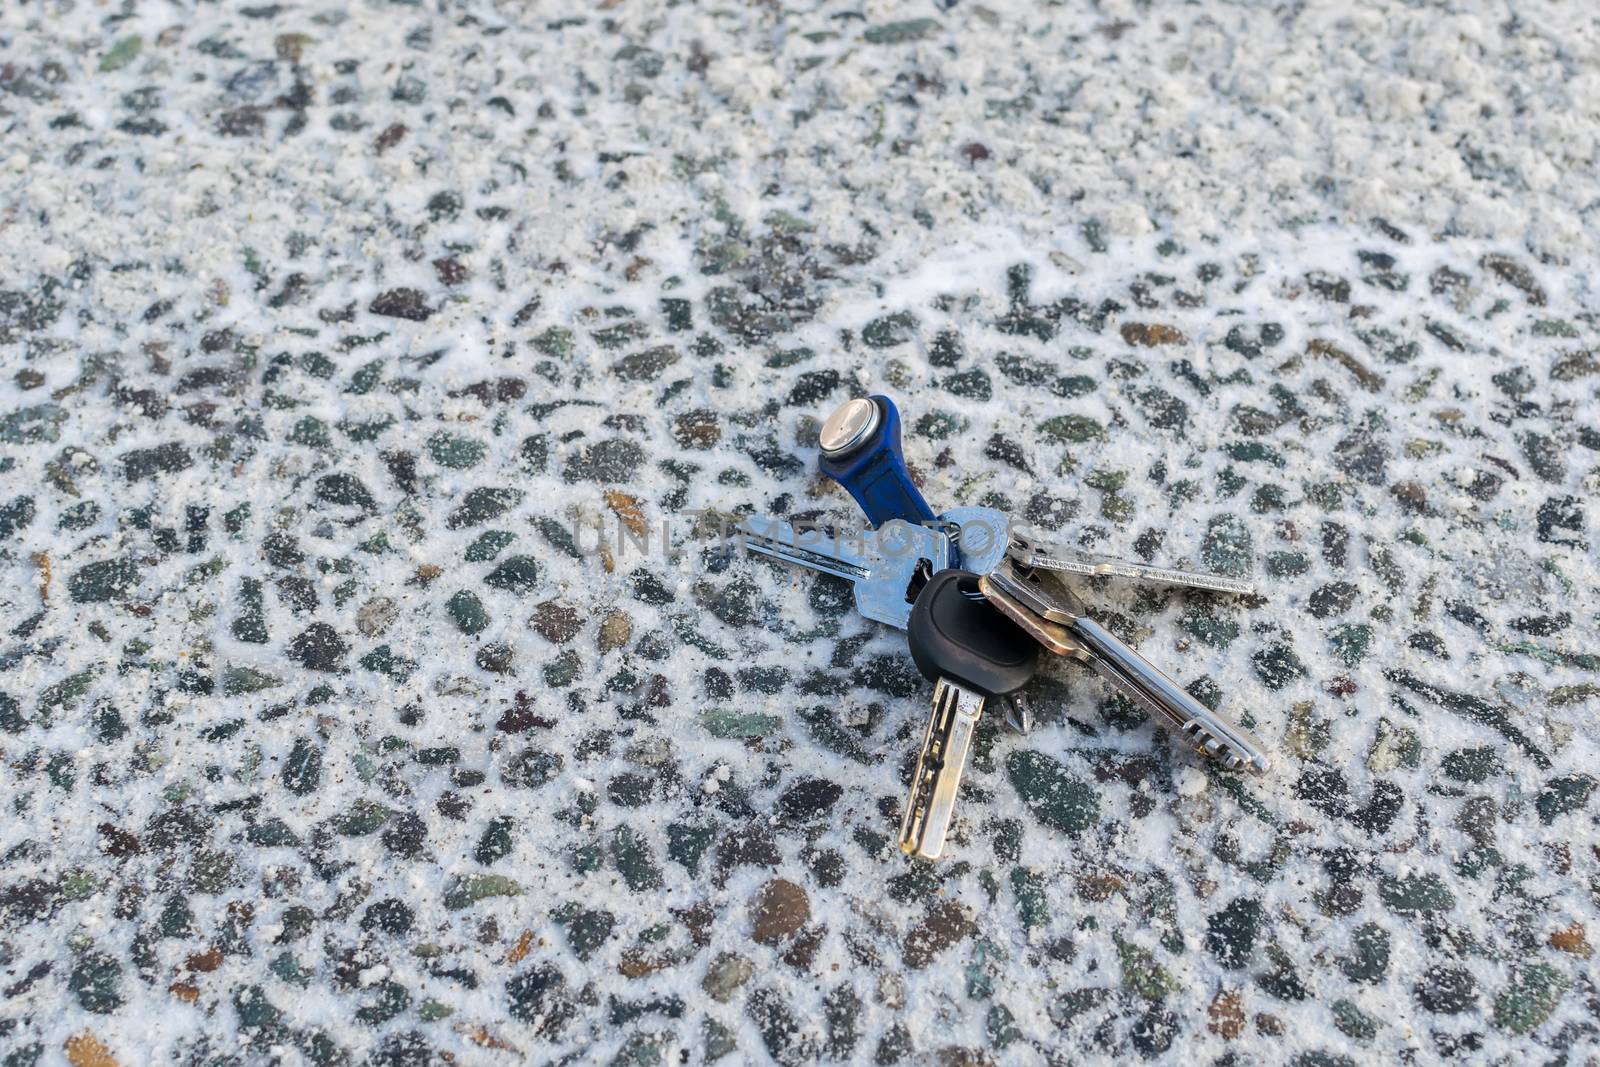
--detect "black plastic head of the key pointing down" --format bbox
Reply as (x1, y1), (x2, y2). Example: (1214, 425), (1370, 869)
(906, 569), (1038, 696)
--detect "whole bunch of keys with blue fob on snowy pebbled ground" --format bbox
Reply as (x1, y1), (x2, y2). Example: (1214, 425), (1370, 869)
(741, 397), (1269, 859)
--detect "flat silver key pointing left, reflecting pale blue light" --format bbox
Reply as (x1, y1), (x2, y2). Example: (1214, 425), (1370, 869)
(738, 517), (950, 630)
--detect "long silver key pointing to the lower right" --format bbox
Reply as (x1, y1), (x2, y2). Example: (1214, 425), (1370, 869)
(979, 560), (1270, 774)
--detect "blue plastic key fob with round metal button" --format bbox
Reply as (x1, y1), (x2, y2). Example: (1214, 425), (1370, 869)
(818, 397), (934, 530)
